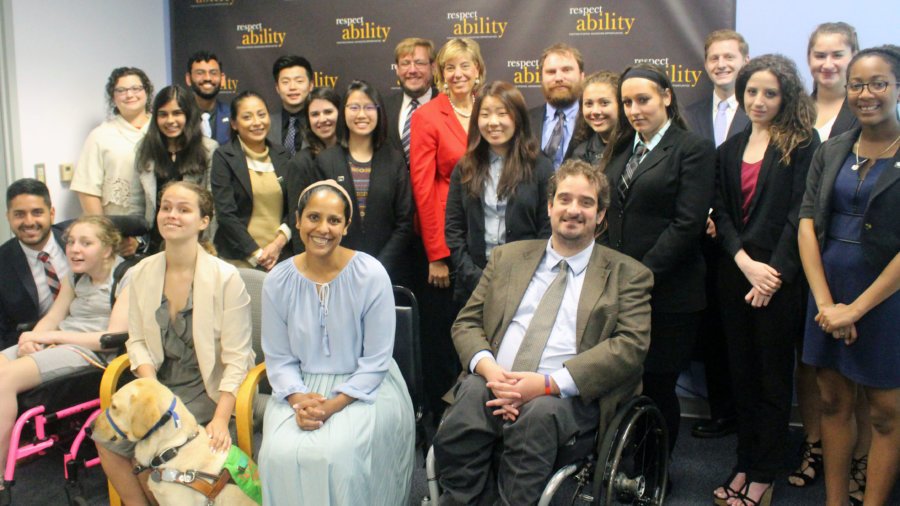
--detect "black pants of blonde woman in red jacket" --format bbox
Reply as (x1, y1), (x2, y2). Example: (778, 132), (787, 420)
(412, 240), (461, 424)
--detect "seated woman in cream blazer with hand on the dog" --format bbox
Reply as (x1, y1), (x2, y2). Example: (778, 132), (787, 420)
(97, 181), (254, 505)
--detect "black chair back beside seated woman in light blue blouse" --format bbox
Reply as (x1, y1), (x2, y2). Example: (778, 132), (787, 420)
(394, 285), (424, 419)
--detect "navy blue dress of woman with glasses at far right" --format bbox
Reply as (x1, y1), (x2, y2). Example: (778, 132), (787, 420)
(803, 153), (900, 388)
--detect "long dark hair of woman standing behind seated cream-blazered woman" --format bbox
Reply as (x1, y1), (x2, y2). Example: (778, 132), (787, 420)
(137, 84), (209, 178)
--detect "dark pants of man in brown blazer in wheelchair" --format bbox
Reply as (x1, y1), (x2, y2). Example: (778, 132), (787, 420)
(434, 374), (600, 506)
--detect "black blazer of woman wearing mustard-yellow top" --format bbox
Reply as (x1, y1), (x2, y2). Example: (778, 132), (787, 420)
(210, 138), (290, 260)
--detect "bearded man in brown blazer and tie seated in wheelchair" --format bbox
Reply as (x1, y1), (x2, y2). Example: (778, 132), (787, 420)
(434, 160), (653, 506)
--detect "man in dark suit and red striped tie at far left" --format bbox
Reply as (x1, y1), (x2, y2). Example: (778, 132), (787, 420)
(0, 179), (69, 348)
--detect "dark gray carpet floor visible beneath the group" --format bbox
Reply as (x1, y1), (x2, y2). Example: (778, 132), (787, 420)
(11, 419), (900, 506)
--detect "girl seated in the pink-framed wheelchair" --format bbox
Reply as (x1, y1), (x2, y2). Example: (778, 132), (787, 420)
(0, 216), (128, 489)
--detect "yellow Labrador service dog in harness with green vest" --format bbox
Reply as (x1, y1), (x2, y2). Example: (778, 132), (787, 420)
(92, 378), (261, 506)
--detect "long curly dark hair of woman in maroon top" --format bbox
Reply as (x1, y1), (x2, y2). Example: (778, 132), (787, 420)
(735, 54), (816, 164)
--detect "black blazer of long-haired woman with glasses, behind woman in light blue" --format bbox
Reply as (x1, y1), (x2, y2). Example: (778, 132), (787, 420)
(315, 144), (413, 279)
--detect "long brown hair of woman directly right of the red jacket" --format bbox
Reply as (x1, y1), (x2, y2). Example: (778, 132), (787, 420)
(459, 81), (538, 199)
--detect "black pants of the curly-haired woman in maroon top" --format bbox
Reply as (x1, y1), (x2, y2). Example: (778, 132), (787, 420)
(719, 258), (802, 483)
